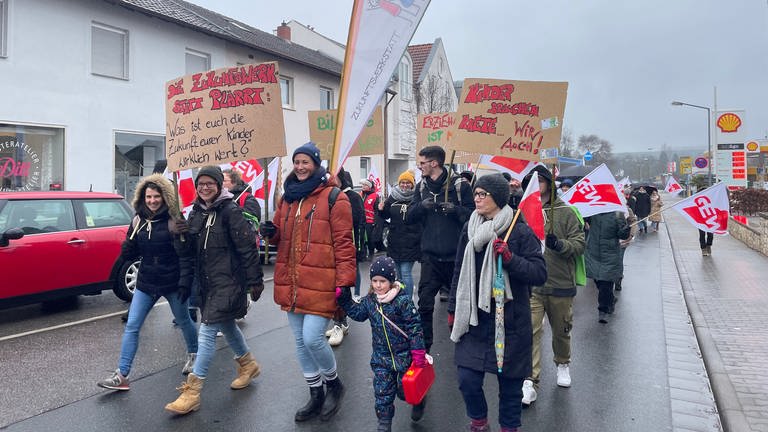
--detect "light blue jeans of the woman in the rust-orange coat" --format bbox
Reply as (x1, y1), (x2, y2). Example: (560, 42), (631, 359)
(288, 312), (336, 378)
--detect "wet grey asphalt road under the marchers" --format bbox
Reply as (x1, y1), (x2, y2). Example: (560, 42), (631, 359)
(0, 238), (672, 432)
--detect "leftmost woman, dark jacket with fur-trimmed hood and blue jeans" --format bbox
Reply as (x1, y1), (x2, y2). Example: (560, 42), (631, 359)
(98, 174), (197, 390)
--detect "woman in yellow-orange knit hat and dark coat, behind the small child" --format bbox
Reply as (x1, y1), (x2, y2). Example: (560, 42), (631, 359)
(379, 171), (422, 297)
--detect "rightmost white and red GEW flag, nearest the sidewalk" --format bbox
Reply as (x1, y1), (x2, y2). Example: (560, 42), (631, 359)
(674, 183), (730, 235)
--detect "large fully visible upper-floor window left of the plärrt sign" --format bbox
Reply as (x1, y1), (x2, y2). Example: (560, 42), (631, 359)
(91, 23), (128, 79)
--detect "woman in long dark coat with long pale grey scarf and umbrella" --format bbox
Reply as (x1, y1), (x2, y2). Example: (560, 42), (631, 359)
(448, 174), (547, 432)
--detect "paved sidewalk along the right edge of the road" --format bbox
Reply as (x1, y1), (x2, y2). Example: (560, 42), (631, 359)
(664, 197), (768, 432)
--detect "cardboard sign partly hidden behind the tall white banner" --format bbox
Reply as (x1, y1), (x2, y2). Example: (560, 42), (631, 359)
(308, 105), (384, 160)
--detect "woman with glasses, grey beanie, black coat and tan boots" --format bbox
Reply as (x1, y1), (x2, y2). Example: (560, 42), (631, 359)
(165, 166), (264, 414)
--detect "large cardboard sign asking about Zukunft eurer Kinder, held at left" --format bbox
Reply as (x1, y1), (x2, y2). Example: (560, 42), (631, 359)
(165, 62), (286, 171)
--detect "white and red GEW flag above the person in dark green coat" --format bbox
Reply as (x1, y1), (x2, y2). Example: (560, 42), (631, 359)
(560, 164), (627, 217)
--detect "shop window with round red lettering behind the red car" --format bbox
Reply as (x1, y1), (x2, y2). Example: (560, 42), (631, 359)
(0, 123), (64, 191)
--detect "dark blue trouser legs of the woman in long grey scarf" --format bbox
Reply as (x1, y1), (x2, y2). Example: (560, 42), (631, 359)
(458, 366), (523, 428)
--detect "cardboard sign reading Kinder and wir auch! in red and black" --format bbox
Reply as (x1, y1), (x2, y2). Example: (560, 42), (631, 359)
(448, 78), (568, 161)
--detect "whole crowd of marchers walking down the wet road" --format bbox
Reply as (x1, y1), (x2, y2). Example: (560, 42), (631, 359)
(98, 142), (640, 432)
